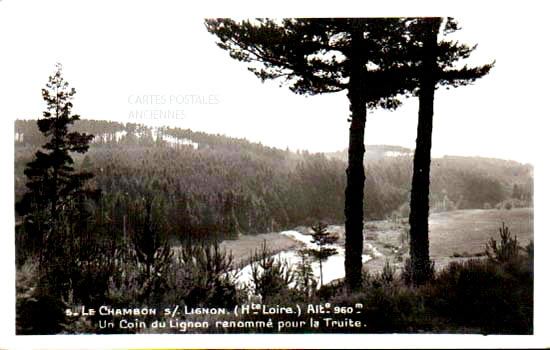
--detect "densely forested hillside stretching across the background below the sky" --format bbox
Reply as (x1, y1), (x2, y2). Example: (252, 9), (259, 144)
(15, 120), (533, 245)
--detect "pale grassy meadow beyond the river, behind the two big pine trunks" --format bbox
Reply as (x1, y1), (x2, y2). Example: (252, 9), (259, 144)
(220, 208), (534, 273)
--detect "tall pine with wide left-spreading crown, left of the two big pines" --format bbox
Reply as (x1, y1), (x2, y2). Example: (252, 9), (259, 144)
(206, 18), (418, 289)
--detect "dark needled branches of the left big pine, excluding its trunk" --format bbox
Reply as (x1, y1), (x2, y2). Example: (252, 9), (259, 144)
(206, 18), (422, 108)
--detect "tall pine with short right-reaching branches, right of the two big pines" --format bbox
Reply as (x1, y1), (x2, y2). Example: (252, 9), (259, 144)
(405, 17), (494, 285)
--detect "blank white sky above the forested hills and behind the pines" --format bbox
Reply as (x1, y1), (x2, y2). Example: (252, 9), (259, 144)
(0, 0), (547, 162)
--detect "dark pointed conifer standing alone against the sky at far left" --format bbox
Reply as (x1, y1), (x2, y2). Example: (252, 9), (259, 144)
(16, 63), (98, 267)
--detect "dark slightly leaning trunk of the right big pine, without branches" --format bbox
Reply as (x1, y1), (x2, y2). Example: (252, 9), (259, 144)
(409, 18), (441, 285)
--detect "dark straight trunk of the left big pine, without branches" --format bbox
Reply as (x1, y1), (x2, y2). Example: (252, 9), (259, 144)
(345, 23), (367, 290)
